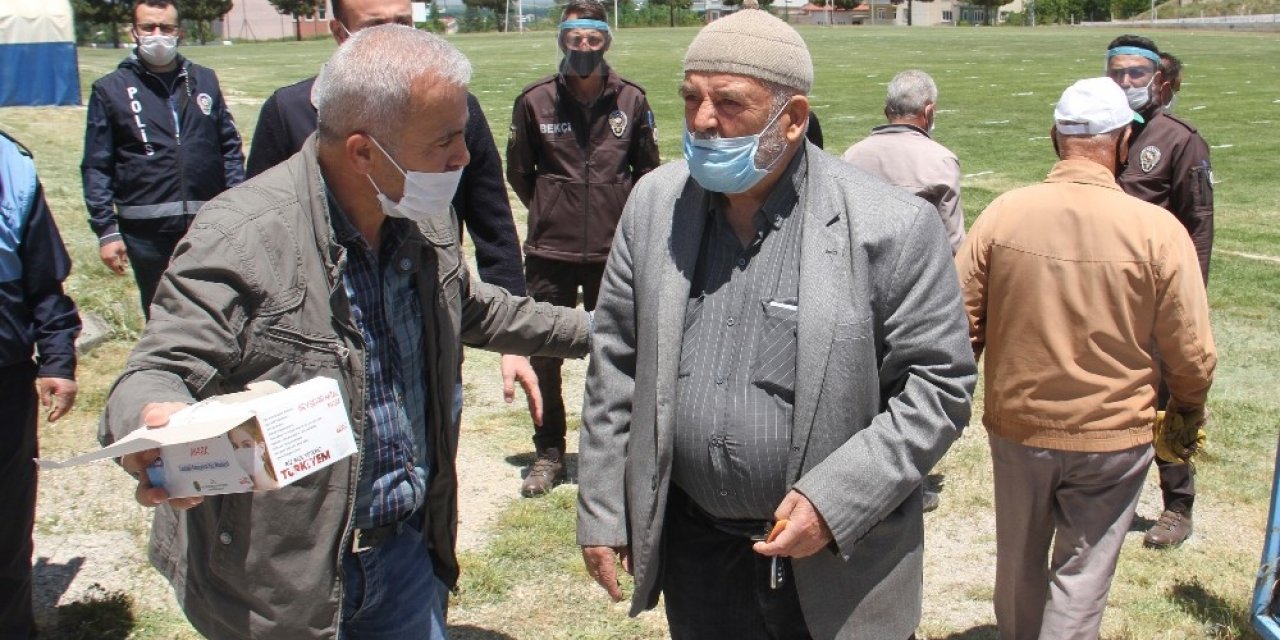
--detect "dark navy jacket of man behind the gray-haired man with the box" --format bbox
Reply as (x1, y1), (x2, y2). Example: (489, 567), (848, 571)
(248, 77), (526, 296)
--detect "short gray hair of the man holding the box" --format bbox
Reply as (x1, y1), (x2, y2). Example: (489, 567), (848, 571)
(315, 24), (471, 146)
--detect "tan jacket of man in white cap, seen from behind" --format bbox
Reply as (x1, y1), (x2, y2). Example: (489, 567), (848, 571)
(956, 160), (1217, 452)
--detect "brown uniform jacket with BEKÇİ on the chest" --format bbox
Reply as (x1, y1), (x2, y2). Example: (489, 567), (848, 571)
(507, 68), (659, 262)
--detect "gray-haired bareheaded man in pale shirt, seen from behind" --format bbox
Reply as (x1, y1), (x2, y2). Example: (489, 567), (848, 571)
(845, 69), (964, 253)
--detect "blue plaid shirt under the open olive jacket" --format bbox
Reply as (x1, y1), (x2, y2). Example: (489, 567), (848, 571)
(329, 197), (430, 529)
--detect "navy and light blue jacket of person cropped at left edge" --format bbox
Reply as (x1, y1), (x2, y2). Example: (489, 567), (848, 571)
(0, 132), (81, 380)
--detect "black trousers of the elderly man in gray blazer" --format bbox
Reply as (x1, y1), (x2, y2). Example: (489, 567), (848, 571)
(662, 486), (810, 640)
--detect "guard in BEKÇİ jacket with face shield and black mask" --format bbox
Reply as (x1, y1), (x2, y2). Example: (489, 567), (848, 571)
(507, 0), (659, 497)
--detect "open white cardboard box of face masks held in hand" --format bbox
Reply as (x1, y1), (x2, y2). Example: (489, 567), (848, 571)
(37, 378), (356, 498)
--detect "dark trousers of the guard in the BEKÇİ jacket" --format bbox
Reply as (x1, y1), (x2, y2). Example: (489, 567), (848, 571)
(525, 256), (604, 453)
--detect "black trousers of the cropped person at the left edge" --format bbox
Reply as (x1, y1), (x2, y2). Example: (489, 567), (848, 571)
(0, 362), (37, 640)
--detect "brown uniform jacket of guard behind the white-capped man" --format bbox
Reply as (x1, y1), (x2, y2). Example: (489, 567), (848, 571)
(1120, 109), (1213, 284)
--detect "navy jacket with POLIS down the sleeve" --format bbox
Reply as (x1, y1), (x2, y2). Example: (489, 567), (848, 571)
(81, 55), (244, 243)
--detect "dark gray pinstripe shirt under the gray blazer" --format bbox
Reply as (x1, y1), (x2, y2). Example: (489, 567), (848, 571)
(672, 147), (808, 520)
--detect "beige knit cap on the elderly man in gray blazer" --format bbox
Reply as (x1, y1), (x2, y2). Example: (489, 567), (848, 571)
(685, 9), (813, 95)
